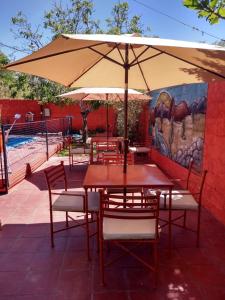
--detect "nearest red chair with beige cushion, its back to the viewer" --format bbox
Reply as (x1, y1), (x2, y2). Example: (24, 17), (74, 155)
(99, 190), (160, 286)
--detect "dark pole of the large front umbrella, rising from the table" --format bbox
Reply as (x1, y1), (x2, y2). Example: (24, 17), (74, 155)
(123, 44), (129, 173)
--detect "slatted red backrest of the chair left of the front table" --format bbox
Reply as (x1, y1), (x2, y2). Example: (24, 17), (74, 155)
(44, 161), (67, 195)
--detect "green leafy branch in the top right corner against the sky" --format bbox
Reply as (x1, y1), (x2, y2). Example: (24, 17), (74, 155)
(183, 0), (225, 24)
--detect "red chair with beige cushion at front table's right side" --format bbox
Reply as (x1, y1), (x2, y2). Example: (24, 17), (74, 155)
(160, 160), (207, 247)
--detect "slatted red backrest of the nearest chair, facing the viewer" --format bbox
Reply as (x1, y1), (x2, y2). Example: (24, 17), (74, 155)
(99, 190), (160, 237)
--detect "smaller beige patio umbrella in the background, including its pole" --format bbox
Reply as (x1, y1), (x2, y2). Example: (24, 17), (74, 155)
(57, 87), (150, 139)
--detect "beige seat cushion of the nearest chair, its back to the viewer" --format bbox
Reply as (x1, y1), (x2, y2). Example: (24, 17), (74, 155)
(103, 217), (156, 240)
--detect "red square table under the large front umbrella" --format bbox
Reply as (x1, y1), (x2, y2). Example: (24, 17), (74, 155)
(83, 164), (174, 249)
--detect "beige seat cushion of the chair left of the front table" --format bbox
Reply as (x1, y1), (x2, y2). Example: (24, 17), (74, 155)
(52, 191), (99, 212)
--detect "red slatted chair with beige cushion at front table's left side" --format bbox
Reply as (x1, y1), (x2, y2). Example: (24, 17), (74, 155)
(44, 162), (99, 258)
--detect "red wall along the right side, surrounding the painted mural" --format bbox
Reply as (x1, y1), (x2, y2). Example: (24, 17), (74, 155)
(145, 82), (225, 224)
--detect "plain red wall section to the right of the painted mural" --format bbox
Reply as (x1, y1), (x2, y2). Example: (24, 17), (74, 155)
(204, 82), (225, 224)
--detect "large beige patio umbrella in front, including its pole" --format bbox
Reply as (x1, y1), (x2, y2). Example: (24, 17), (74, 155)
(6, 34), (225, 172)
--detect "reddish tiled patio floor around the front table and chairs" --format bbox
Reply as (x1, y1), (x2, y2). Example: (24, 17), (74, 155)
(0, 157), (225, 300)
